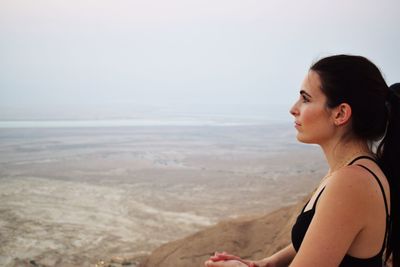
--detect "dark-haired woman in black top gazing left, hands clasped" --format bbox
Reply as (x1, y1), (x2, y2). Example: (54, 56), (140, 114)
(205, 55), (400, 267)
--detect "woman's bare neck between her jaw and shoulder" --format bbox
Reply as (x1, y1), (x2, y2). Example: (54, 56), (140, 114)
(321, 140), (372, 174)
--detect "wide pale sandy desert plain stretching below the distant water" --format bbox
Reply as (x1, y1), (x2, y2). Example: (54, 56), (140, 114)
(0, 125), (325, 266)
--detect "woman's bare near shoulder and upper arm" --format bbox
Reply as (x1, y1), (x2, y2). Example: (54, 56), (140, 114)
(293, 166), (376, 266)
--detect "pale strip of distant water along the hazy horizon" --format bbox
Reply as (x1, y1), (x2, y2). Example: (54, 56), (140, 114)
(0, 102), (292, 129)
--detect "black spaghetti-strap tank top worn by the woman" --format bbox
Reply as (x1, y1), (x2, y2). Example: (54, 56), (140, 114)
(292, 156), (390, 267)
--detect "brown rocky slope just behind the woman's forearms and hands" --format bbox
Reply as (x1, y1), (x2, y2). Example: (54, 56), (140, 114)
(141, 201), (304, 267)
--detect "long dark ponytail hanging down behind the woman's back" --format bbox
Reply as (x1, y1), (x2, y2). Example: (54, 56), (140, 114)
(377, 83), (400, 267)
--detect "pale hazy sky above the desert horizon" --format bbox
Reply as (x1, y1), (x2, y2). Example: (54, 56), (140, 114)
(0, 0), (400, 119)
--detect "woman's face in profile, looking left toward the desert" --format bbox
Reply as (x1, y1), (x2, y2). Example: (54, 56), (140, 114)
(290, 71), (335, 144)
